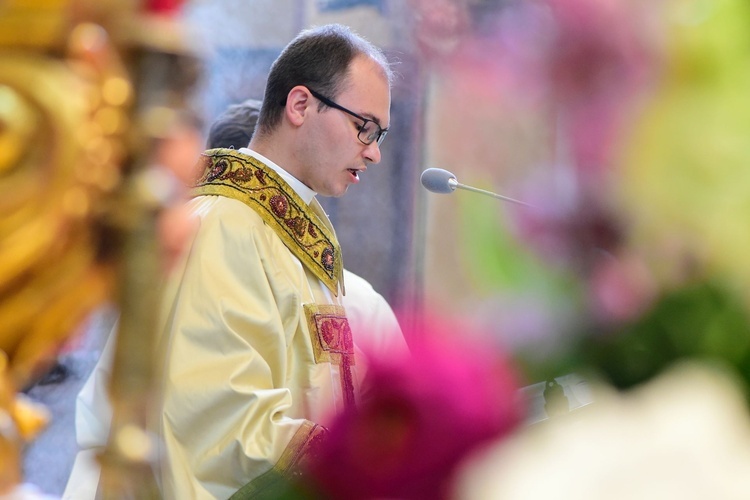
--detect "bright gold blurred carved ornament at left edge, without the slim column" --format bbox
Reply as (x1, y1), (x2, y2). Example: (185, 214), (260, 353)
(0, 25), (132, 387)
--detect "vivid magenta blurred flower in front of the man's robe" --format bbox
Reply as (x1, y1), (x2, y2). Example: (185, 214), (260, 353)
(311, 318), (524, 500)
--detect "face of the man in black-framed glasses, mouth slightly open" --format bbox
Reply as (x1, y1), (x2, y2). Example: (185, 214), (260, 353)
(300, 53), (391, 197)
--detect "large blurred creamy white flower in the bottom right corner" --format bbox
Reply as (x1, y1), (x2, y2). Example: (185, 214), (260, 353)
(454, 364), (750, 500)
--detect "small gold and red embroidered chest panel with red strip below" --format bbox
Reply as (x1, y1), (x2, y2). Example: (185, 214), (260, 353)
(304, 304), (355, 407)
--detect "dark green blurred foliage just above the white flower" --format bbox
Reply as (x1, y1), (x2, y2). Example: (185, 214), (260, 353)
(576, 282), (750, 396)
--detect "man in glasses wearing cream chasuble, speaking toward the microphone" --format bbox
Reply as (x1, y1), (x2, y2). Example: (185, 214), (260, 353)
(160, 25), (392, 499)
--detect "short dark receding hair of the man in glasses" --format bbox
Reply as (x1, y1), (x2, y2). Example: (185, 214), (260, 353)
(258, 24), (393, 137)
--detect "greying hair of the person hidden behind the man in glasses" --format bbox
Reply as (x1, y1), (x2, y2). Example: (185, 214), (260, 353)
(206, 99), (261, 149)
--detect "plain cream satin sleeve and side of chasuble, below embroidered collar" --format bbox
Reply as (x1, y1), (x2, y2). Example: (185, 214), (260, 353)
(161, 196), (317, 498)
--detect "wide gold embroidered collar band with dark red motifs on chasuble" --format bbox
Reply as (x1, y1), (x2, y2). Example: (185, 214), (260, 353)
(192, 149), (343, 295)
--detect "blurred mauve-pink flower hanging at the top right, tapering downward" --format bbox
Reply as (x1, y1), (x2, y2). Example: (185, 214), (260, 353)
(542, 0), (652, 175)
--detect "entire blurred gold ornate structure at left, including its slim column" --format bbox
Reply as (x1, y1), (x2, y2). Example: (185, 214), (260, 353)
(0, 0), (197, 498)
